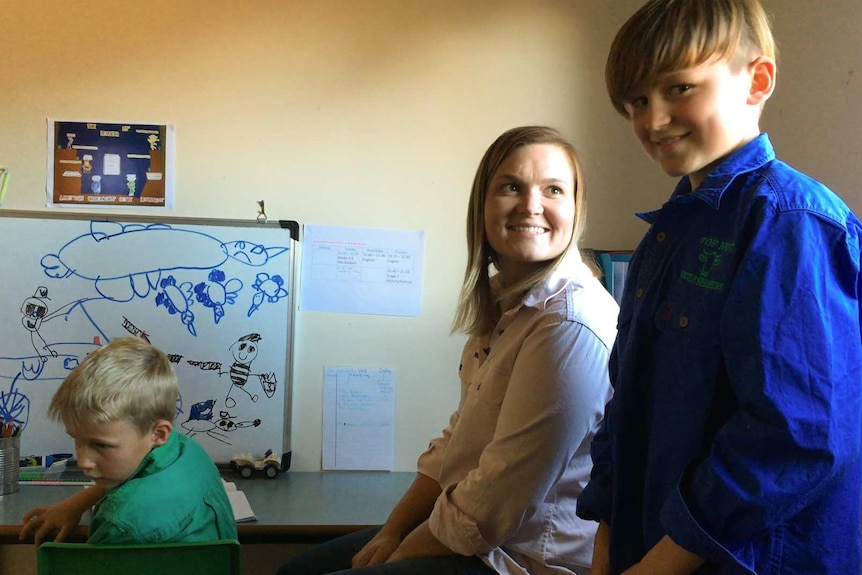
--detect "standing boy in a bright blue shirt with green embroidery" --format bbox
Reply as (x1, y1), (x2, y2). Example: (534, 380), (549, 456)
(577, 0), (862, 575)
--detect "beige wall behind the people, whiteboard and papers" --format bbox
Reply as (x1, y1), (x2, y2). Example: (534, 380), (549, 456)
(0, 0), (862, 471)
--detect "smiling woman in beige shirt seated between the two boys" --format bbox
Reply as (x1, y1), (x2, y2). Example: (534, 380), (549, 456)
(279, 126), (618, 575)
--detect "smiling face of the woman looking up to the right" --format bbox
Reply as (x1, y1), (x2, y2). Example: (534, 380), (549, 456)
(485, 144), (575, 285)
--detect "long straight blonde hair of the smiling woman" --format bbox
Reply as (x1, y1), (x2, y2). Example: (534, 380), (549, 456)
(452, 126), (586, 335)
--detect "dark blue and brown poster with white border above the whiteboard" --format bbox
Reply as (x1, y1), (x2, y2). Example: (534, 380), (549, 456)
(47, 119), (174, 209)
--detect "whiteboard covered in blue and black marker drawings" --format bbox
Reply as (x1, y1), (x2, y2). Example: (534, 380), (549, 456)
(0, 211), (299, 469)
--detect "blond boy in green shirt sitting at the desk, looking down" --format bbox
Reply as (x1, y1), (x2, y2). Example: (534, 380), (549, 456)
(21, 337), (237, 545)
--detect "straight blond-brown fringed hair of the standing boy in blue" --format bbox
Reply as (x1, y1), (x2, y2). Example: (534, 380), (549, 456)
(605, 0), (777, 117)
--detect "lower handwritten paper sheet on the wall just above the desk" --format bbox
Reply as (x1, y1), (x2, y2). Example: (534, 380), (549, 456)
(322, 367), (395, 471)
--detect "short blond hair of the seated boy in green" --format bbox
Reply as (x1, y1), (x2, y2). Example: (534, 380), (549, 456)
(48, 337), (179, 435)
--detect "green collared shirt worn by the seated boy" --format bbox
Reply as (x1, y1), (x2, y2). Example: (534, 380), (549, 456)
(87, 431), (237, 544)
